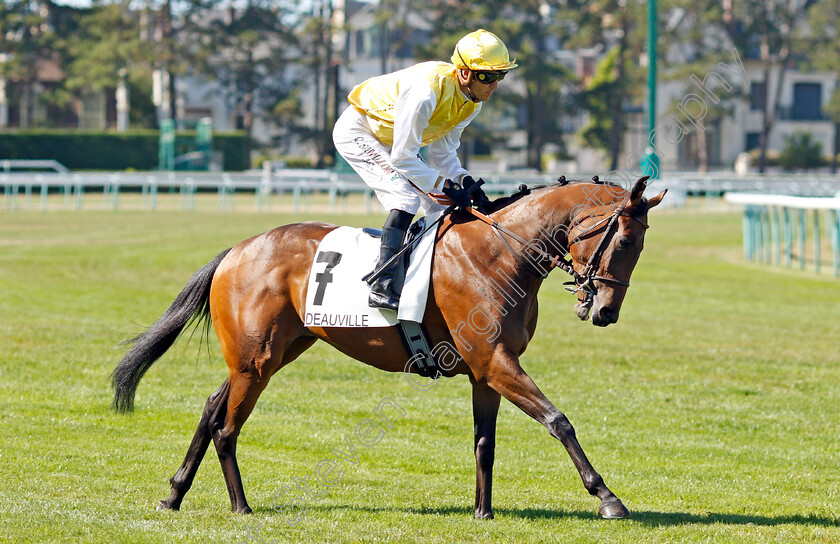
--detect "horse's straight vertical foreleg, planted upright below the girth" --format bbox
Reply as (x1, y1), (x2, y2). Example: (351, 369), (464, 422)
(473, 381), (502, 519)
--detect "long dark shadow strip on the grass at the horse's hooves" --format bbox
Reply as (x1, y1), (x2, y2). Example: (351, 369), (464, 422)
(255, 505), (840, 527)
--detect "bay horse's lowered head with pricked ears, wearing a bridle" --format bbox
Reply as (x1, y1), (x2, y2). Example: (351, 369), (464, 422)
(569, 177), (667, 327)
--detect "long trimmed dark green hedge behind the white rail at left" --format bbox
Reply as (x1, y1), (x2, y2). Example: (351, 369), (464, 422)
(0, 130), (251, 170)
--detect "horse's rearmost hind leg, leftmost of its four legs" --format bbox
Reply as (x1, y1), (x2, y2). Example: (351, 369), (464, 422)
(158, 380), (230, 510)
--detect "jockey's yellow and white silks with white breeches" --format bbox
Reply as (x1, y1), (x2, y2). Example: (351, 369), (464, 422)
(333, 62), (481, 213)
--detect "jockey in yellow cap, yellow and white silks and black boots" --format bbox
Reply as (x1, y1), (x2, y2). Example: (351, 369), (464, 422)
(333, 30), (517, 310)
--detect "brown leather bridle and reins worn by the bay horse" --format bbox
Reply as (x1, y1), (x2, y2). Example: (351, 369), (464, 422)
(467, 193), (648, 302)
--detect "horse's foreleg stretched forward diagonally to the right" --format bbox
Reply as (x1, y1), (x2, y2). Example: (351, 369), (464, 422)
(487, 355), (630, 519)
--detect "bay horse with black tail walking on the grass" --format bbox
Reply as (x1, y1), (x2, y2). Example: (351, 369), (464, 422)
(111, 178), (665, 519)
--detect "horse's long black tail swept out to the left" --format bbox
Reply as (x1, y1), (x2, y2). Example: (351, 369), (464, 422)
(111, 249), (230, 413)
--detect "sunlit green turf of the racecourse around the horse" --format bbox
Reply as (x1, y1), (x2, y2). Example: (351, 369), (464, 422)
(0, 204), (840, 543)
